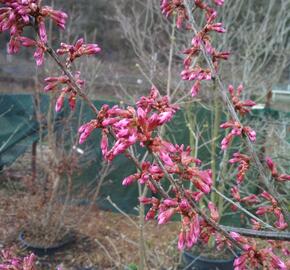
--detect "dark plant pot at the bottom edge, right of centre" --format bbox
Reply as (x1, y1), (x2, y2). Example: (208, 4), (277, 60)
(183, 251), (235, 270)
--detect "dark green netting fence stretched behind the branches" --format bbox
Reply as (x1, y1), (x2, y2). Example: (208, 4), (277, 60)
(0, 95), (290, 213)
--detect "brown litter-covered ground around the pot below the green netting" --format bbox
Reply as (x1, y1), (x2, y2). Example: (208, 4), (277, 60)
(0, 187), (179, 270)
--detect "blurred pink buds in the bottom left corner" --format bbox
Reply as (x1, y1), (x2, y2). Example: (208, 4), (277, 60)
(0, 250), (36, 270)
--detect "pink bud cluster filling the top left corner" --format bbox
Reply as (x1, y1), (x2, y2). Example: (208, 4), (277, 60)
(0, 0), (67, 65)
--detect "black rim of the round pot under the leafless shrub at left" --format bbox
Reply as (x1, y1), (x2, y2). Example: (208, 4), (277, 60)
(18, 231), (75, 256)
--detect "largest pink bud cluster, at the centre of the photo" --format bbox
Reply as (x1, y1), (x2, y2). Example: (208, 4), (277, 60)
(79, 87), (178, 160)
